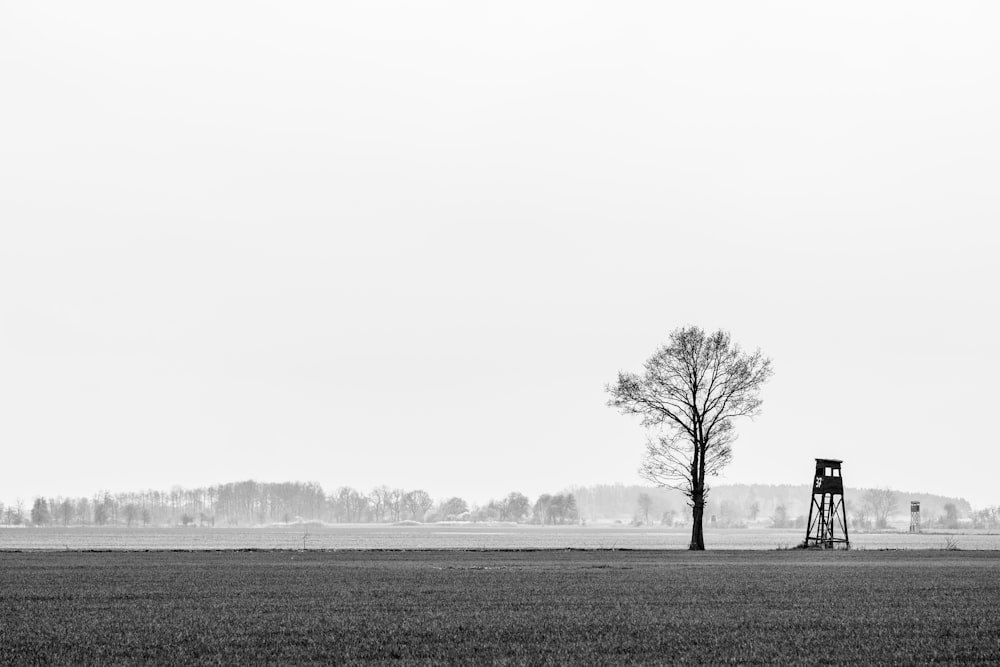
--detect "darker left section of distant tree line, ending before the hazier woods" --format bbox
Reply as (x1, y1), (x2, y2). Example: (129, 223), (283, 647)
(0, 480), (580, 527)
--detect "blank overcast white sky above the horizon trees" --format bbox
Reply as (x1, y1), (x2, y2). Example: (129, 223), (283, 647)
(0, 0), (1000, 506)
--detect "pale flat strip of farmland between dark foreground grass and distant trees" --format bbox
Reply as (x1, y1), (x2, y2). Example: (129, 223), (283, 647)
(0, 523), (1000, 551)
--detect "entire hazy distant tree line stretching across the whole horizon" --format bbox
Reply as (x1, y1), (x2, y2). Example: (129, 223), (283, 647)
(0, 480), (984, 530)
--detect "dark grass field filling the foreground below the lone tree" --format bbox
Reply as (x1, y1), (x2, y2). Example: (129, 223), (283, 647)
(0, 550), (1000, 665)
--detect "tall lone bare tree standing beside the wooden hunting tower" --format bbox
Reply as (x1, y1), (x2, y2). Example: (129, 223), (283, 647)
(607, 327), (772, 550)
